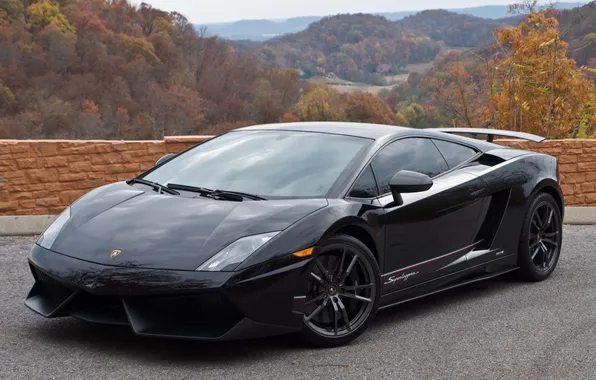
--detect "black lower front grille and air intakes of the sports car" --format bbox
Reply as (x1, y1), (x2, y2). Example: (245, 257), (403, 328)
(28, 265), (244, 339)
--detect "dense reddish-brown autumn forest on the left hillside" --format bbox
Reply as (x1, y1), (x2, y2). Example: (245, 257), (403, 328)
(0, 0), (301, 139)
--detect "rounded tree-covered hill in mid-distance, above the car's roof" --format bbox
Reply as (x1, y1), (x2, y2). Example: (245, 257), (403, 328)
(251, 14), (442, 84)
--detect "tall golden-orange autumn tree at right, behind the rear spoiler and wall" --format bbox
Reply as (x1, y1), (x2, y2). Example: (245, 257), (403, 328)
(489, 0), (596, 138)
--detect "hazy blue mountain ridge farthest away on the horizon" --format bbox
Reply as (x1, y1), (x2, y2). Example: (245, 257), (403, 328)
(196, 0), (586, 41)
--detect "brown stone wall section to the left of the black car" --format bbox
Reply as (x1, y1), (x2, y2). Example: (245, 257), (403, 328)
(0, 136), (208, 215)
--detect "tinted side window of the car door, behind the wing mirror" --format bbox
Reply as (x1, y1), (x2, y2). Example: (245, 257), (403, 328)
(373, 138), (449, 194)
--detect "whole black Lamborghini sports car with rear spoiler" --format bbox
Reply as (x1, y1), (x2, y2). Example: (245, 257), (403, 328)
(25, 123), (564, 346)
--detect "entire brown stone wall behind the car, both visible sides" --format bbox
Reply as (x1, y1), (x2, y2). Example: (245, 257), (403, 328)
(0, 136), (596, 215)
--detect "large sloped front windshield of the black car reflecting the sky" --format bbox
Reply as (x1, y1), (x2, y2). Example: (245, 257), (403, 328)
(144, 130), (372, 197)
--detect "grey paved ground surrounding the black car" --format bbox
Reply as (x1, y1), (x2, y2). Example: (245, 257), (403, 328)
(0, 227), (596, 380)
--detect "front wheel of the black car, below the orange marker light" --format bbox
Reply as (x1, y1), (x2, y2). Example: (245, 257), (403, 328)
(300, 235), (381, 347)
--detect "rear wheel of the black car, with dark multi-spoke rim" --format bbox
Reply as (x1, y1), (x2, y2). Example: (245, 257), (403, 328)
(518, 193), (563, 282)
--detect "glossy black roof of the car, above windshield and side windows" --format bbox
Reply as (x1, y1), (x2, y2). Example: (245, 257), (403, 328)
(236, 121), (503, 152)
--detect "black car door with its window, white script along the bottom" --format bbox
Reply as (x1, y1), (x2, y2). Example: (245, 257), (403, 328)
(372, 138), (487, 292)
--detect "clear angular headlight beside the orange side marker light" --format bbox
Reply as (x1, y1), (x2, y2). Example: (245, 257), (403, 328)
(197, 231), (280, 272)
